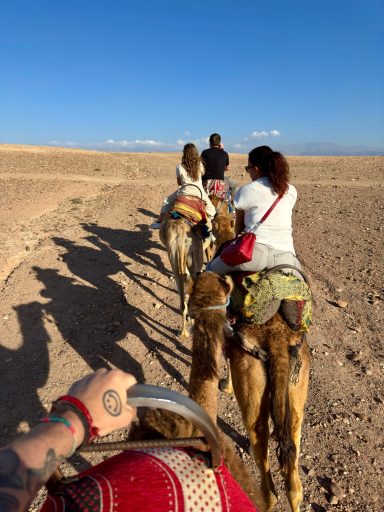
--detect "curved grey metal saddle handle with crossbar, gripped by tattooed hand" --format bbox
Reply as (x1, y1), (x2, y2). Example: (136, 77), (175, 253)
(81, 384), (222, 468)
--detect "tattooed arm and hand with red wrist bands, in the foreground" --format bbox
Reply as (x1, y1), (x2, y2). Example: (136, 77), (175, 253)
(0, 369), (136, 511)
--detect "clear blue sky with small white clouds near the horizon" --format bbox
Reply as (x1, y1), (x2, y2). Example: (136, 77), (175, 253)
(0, 0), (384, 152)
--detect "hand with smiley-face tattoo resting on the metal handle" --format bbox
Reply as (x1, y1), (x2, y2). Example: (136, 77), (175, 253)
(68, 368), (136, 436)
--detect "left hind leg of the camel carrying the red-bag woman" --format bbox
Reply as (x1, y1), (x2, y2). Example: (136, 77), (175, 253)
(231, 347), (277, 511)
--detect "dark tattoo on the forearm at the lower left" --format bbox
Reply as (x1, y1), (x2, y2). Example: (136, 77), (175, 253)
(0, 448), (62, 512)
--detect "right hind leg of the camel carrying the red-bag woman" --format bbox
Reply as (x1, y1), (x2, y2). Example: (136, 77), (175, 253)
(285, 346), (309, 512)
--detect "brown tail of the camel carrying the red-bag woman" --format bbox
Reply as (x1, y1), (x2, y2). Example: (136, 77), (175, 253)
(269, 337), (297, 474)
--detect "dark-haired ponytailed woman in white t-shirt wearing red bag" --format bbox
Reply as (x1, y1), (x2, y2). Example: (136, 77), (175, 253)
(207, 146), (301, 274)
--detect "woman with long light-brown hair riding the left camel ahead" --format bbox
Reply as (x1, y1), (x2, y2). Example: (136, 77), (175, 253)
(151, 143), (216, 230)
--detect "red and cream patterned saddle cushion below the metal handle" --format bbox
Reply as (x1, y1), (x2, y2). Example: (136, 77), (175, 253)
(41, 448), (257, 512)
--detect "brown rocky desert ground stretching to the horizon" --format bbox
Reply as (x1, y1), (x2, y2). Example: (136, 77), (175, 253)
(0, 145), (384, 512)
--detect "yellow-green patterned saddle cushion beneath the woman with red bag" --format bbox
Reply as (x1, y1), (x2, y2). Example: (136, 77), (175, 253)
(231, 271), (312, 332)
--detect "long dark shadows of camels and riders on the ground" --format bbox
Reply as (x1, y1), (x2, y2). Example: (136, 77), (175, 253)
(0, 224), (190, 442)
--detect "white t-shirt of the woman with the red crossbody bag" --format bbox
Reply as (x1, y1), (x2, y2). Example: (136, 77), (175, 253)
(234, 177), (297, 254)
